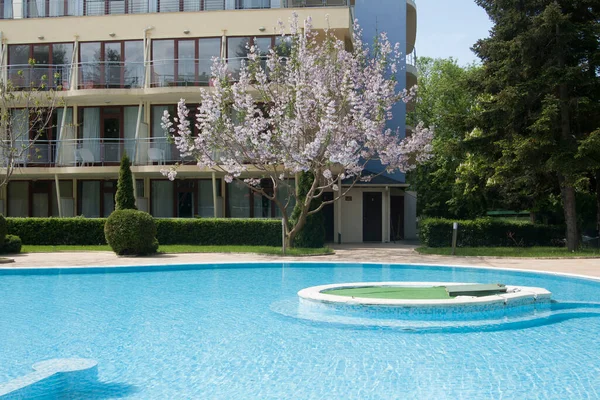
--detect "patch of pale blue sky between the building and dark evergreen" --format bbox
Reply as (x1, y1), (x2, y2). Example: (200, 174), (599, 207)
(416, 0), (492, 65)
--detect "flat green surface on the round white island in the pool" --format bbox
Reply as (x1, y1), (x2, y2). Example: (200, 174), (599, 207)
(321, 286), (454, 300)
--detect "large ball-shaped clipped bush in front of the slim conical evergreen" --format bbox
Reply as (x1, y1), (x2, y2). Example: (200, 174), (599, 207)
(104, 209), (158, 256)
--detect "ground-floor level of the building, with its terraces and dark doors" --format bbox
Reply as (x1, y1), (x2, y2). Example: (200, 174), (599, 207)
(0, 174), (416, 243)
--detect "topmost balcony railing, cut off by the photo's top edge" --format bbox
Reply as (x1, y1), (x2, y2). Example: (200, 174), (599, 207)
(0, 0), (354, 19)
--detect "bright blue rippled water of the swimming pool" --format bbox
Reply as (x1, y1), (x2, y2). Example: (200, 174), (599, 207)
(0, 263), (600, 400)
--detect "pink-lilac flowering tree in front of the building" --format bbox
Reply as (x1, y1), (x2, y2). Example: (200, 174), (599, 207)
(163, 15), (432, 246)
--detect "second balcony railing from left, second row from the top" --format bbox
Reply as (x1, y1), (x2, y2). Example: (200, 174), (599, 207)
(78, 61), (144, 89)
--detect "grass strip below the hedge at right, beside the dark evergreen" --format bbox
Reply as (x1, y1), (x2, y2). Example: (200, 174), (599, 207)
(417, 247), (600, 258)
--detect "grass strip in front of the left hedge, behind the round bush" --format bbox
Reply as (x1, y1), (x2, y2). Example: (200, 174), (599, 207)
(21, 244), (333, 256)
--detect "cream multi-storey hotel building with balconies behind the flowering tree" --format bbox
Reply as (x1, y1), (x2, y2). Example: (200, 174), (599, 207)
(0, 0), (416, 242)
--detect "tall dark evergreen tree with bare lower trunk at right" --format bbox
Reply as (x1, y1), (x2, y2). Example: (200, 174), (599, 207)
(474, 0), (600, 250)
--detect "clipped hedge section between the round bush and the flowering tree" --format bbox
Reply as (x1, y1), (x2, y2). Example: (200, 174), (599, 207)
(156, 218), (281, 246)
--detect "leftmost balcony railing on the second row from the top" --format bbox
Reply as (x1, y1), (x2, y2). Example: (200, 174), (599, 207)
(4, 64), (71, 90)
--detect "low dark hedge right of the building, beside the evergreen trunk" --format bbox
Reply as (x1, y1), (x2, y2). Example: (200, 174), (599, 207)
(419, 218), (565, 247)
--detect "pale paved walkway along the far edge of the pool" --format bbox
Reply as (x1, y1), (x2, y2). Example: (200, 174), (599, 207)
(0, 243), (600, 278)
